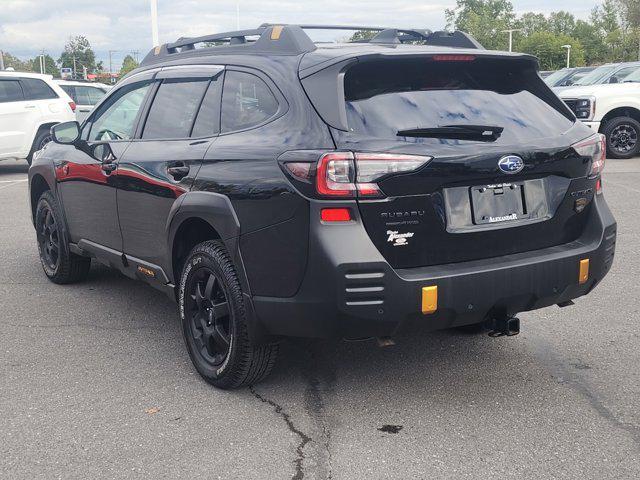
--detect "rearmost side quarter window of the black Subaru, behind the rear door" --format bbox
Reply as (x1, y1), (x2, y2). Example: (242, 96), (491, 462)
(222, 71), (278, 132)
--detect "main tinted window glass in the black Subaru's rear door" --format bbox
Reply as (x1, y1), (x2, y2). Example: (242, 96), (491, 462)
(142, 80), (209, 140)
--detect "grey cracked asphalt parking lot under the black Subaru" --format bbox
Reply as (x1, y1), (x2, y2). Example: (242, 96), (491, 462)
(0, 159), (640, 479)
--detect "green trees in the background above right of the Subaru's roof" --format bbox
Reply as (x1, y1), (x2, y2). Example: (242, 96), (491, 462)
(445, 0), (640, 70)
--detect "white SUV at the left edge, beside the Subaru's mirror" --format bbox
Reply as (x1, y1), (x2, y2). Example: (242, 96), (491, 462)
(0, 71), (76, 164)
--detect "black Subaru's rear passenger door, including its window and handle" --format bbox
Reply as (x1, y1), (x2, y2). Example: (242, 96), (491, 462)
(118, 66), (223, 271)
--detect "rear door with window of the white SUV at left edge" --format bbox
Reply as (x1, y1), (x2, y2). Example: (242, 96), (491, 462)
(0, 77), (32, 156)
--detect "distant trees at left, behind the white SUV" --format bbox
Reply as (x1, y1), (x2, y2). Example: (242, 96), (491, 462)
(3, 35), (138, 78)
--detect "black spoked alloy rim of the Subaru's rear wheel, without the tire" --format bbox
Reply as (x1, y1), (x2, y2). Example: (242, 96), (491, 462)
(185, 266), (232, 367)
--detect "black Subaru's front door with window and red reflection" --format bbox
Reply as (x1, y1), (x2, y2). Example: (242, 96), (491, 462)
(56, 80), (152, 253)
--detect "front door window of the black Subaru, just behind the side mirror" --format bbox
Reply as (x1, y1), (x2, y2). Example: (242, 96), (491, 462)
(89, 82), (151, 141)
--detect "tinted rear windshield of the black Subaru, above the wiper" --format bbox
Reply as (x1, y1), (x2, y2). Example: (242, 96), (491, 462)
(345, 59), (574, 143)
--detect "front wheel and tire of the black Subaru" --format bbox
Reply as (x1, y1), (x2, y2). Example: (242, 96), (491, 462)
(35, 190), (91, 284)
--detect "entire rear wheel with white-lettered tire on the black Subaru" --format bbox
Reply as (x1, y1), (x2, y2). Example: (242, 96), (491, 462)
(178, 241), (279, 389)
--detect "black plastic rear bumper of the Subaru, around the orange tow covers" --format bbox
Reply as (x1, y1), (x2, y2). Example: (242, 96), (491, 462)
(253, 196), (616, 338)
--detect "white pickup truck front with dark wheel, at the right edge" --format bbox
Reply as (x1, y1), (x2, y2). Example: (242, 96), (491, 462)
(559, 70), (640, 158)
